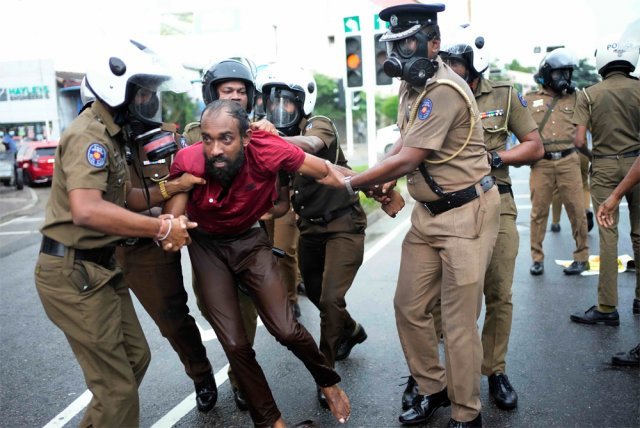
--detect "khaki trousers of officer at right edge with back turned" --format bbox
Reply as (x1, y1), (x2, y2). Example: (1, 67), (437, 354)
(591, 157), (640, 306)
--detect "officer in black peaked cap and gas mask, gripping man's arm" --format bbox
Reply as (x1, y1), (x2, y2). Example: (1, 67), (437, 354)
(327, 4), (500, 427)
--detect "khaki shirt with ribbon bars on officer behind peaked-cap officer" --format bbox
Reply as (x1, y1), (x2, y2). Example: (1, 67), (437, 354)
(475, 78), (538, 184)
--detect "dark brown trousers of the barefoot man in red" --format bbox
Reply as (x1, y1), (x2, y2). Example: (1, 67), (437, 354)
(189, 228), (340, 426)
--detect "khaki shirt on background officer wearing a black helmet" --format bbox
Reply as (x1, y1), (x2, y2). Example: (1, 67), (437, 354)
(525, 88), (576, 152)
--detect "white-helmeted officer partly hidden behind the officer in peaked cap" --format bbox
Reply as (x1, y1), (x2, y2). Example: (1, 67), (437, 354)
(440, 27), (544, 410)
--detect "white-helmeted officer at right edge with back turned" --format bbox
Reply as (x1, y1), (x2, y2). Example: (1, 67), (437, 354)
(571, 40), (640, 326)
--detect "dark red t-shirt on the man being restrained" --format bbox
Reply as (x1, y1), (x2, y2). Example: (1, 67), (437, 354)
(171, 131), (305, 235)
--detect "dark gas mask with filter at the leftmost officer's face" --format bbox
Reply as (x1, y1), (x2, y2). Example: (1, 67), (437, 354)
(123, 85), (178, 162)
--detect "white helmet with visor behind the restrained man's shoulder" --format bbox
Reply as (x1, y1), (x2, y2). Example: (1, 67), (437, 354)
(256, 63), (318, 135)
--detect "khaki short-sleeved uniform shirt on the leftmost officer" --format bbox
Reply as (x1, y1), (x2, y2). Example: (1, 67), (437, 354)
(41, 101), (128, 249)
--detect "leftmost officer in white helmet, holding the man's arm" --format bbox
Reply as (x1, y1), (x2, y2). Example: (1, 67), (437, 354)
(35, 41), (196, 427)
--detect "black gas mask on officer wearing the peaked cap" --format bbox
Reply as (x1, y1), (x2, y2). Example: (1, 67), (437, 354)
(383, 31), (438, 87)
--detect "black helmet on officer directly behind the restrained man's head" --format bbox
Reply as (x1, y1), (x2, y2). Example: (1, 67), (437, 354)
(202, 59), (255, 113)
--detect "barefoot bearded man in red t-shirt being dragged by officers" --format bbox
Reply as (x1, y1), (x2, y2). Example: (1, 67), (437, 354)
(164, 100), (350, 427)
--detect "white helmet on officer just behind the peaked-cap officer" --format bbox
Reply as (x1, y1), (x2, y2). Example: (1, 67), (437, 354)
(440, 24), (489, 82)
